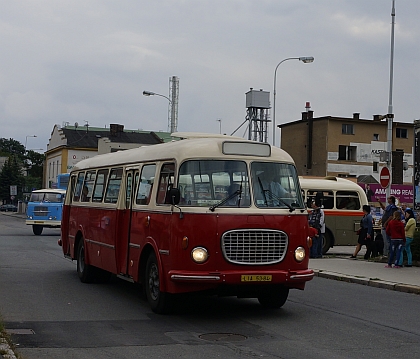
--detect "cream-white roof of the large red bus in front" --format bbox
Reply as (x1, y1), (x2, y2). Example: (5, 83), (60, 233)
(73, 133), (294, 171)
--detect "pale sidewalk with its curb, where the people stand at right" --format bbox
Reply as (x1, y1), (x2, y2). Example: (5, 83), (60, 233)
(309, 246), (420, 294)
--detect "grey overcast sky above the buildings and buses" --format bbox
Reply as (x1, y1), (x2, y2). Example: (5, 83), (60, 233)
(0, 0), (420, 150)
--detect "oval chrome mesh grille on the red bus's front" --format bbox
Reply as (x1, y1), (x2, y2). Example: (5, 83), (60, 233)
(222, 229), (288, 265)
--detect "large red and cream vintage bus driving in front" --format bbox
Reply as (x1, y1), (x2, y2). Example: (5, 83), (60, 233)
(59, 134), (314, 313)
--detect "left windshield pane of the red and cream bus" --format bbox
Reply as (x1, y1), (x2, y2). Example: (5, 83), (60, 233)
(178, 160), (250, 207)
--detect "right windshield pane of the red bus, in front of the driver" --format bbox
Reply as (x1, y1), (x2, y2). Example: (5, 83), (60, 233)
(251, 162), (304, 209)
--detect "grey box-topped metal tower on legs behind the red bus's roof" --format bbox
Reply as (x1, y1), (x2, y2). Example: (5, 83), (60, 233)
(246, 88), (271, 142)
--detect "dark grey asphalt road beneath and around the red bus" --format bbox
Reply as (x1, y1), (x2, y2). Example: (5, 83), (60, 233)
(0, 215), (420, 359)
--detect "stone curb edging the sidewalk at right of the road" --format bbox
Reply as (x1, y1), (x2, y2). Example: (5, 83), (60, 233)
(313, 269), (420, 294)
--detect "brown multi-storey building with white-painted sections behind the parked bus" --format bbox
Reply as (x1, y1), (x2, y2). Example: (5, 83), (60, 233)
(278, 111), (414, 185)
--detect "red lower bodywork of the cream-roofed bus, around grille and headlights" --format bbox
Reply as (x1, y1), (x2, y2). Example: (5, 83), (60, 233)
(61, 206), (313, 293)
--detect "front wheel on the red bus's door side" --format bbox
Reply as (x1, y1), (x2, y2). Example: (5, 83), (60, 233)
(143, 252), (170, 314)
